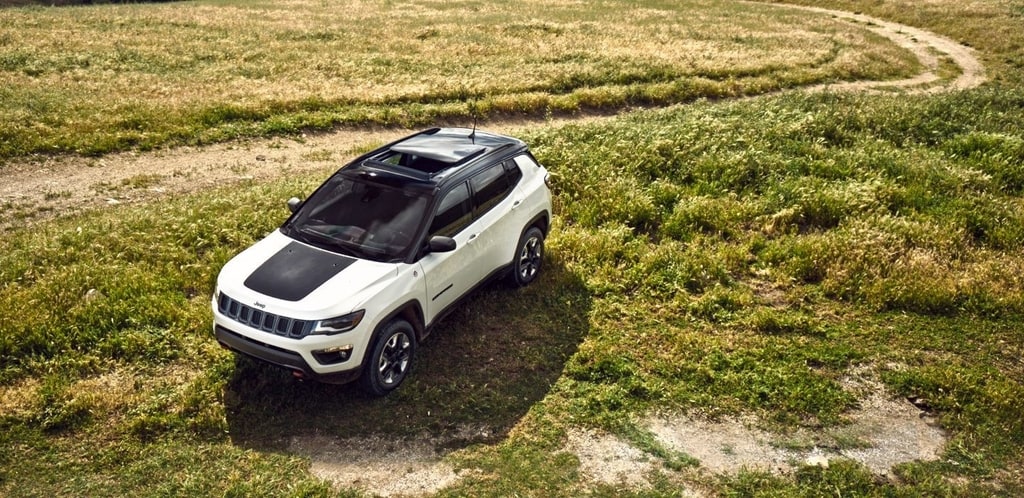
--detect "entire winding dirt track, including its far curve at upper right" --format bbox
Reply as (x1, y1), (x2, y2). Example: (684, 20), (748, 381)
(0, 5), (985, 233)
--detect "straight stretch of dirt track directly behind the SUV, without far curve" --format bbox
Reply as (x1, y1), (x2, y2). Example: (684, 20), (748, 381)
(0, 117), (604, 233)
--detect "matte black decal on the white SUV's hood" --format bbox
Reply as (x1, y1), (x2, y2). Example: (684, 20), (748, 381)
(246, 242), (355, 301)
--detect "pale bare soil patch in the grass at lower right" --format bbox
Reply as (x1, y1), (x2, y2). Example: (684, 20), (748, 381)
(565, 373), (947, 493)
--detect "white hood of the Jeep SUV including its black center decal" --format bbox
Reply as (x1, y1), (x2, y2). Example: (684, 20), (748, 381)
(217, 231), (397, 318)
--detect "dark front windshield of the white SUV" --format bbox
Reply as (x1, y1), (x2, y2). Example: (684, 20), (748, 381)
(284, 175), (427, 261)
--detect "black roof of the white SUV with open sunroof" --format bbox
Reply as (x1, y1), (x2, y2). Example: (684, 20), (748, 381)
(343, 128), (526, 188)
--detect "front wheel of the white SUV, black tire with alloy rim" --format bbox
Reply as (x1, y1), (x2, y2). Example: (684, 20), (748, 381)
(359, 320), (416, 397)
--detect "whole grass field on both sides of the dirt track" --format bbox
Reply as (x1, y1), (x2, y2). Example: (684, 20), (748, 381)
(0, 0), (1024, 496)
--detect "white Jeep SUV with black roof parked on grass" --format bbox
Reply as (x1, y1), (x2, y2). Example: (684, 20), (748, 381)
(212, 128), (551, 396)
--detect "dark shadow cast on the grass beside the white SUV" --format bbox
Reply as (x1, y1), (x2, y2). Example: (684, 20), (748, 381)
(224, 259), (591, 450)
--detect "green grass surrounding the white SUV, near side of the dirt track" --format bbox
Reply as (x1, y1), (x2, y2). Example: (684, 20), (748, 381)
(0, 90), (1024, 495)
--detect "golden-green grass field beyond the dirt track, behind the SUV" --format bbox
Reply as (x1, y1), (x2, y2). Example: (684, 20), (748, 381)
(0, 0), (919, 161)
